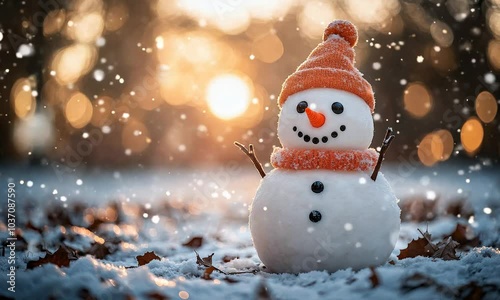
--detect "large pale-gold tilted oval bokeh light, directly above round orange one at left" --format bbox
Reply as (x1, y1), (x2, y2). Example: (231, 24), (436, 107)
(51, 44), (97, 85)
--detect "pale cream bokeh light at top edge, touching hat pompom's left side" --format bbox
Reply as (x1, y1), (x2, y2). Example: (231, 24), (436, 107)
(297, 0), (335, 38)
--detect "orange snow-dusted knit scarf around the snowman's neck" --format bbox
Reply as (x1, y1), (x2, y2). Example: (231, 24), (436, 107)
(271, 147), (378, 171)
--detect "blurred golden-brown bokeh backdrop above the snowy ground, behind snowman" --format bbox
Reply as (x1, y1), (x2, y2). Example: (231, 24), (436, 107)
(0, 0), (500, 172)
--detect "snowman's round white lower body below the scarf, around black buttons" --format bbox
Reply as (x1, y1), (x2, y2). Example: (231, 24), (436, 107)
(250, 169), (400, 273)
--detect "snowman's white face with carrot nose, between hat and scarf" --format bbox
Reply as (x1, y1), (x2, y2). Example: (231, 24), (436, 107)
(278, 88), (373, 150)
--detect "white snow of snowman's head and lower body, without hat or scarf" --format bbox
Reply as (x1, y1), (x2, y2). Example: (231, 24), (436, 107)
(250, 88), (400, 273)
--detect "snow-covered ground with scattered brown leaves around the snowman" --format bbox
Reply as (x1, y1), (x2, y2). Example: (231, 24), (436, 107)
(0, 165), (500, 299)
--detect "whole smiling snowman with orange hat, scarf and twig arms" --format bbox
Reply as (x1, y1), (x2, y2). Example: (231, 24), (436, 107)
(235, 21), (400, 273)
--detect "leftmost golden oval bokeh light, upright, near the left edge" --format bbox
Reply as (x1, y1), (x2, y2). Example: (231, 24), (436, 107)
(10, 78), (36, 119)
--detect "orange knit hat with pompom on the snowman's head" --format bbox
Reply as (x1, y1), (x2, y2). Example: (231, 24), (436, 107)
(278, 20), (375, 113)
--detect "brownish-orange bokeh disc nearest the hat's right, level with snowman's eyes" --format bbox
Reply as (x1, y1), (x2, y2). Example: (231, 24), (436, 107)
(404, 82), (433, 118)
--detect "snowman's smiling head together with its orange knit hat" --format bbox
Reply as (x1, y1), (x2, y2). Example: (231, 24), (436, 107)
(278, 20), (375, 150)
